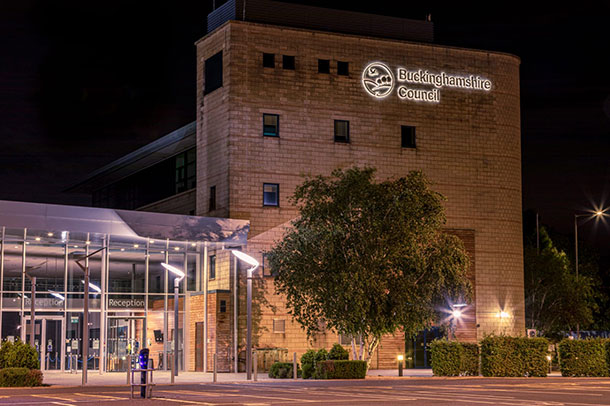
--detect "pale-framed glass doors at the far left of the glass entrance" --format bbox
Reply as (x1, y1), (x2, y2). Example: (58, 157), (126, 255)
(25, 315), (64, 370)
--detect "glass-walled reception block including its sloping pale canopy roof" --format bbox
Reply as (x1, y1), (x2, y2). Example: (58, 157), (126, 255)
(0, 200), (249, 371)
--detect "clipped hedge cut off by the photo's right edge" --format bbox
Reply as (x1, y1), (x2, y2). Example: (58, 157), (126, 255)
(559, 338), (610, 376)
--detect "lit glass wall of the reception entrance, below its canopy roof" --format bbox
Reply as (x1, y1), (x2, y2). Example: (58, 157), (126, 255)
(0, 227), (203, 371)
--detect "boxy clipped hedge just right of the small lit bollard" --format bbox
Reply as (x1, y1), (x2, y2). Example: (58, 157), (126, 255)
(430, 340), (479, 376)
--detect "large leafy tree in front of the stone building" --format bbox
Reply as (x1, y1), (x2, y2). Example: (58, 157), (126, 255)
(268, 168), (472, 362)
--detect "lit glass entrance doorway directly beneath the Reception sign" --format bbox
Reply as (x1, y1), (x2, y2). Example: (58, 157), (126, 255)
(106, 317), (146, 372)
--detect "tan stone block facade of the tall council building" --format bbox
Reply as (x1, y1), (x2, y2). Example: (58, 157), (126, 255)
(196, 21), (524, 368)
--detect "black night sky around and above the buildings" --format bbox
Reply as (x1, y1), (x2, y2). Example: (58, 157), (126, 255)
(0, 0), (610, 252)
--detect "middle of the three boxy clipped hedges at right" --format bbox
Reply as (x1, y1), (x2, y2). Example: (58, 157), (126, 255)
(481, 335), (549, 376)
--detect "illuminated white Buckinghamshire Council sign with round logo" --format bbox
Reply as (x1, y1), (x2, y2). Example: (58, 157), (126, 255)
(362, 62), (492, 103)
